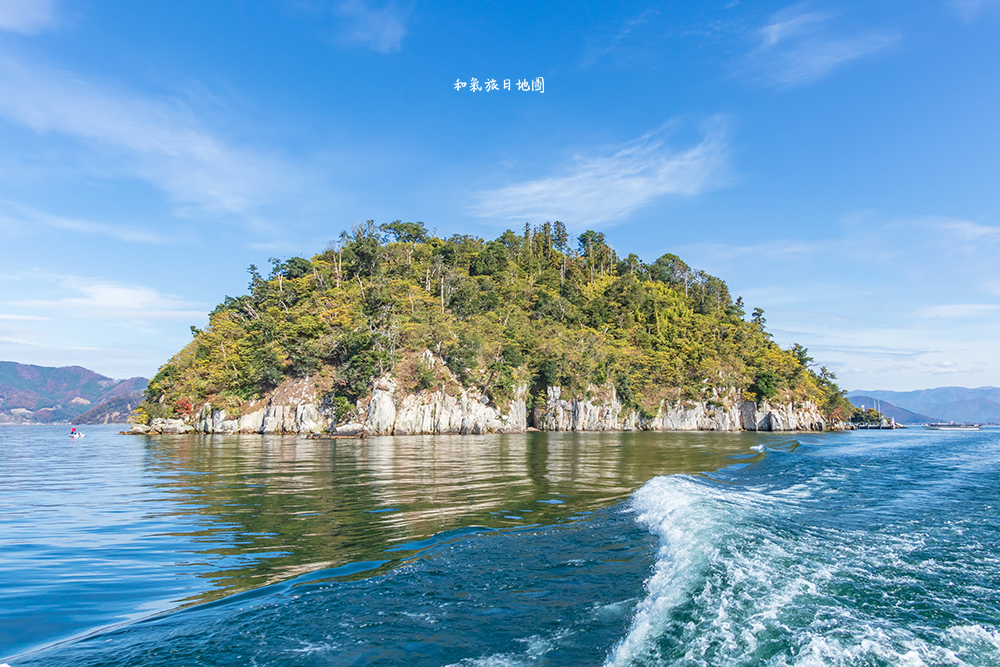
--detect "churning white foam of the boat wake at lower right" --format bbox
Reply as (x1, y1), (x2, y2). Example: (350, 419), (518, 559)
(605, 476), (1000, 667)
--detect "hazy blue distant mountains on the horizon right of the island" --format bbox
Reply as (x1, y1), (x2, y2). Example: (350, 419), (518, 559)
(847, 387), (1000, 424)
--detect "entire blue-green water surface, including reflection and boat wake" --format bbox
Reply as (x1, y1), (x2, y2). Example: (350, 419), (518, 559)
(0, 426), (1000, 667)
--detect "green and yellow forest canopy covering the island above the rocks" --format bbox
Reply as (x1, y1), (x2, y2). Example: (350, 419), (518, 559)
(135, 220), (853, 421)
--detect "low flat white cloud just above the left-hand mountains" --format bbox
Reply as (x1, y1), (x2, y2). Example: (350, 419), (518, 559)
(5, 276), (206, 321)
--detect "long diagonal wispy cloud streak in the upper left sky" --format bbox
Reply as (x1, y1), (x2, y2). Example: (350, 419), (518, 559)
(0, 54), (296, 213)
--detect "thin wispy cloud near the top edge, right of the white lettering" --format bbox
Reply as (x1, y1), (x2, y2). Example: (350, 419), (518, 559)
(745, 5), (901, 88)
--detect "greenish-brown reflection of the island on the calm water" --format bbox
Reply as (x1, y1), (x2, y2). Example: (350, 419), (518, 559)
(141, 432), (768, 602)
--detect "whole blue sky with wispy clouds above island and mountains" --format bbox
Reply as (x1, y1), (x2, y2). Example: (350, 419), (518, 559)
(0, 0), (1000, 390)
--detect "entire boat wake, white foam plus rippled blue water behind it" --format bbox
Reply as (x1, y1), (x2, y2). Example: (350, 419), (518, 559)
(605, 436), (1000, 666)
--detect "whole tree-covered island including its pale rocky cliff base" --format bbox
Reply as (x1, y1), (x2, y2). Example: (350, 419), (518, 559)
(133, 220), (853, 433)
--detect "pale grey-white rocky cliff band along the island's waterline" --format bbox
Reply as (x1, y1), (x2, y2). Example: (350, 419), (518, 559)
(133, 353), (828, 435)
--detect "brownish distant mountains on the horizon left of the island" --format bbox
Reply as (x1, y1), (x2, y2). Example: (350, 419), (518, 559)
(0, 361), (149, 424)
